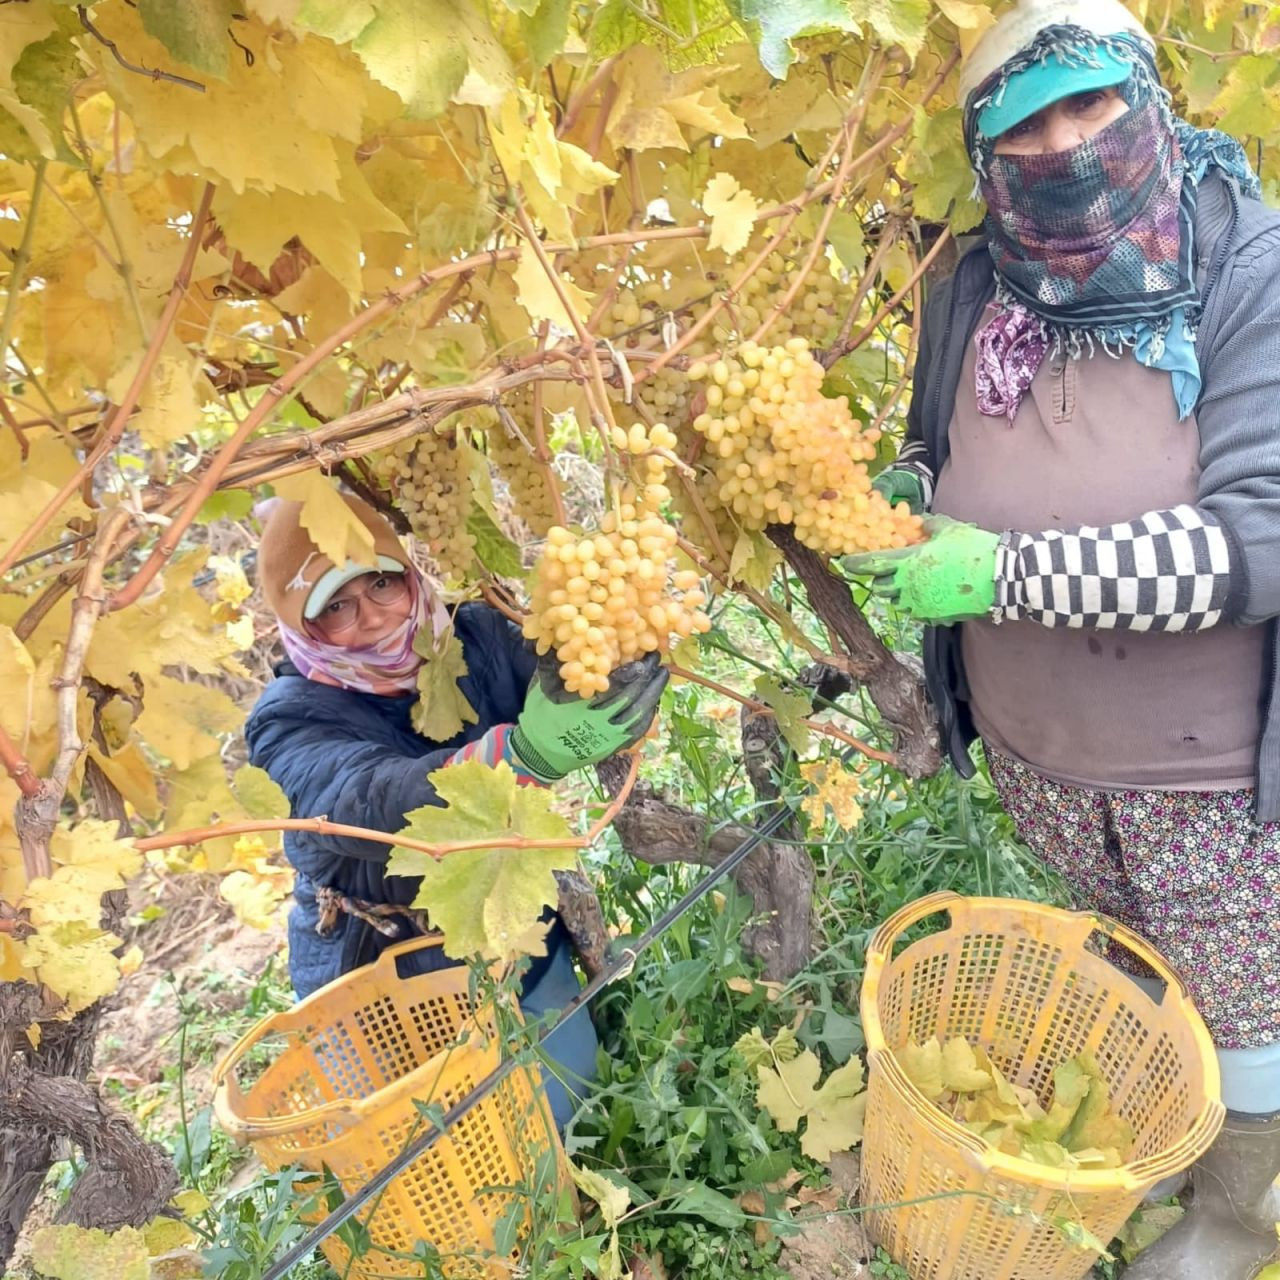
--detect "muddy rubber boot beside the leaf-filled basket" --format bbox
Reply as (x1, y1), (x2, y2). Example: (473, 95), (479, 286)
(1124, 1111), (1280, 1280)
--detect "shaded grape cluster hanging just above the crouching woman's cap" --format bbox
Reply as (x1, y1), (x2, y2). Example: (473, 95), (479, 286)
(375, 425), (475, 577)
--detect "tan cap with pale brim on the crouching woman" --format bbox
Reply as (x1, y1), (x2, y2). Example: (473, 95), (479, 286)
(257, 494), (410, 634)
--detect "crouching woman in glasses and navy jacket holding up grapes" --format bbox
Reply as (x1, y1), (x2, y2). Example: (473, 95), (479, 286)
(244, 498), (667, 1128)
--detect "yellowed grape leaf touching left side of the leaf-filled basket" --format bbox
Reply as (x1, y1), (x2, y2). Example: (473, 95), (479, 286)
(755, 1048), (867, 1161)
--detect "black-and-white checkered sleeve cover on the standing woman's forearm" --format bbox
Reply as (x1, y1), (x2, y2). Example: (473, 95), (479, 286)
(993, 504), (1231, 631)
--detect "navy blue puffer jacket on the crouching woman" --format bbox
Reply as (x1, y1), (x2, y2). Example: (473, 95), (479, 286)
(244, 604), (563, 998)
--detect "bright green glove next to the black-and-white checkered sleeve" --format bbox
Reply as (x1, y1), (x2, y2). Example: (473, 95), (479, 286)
(840, 516), (1000, 622)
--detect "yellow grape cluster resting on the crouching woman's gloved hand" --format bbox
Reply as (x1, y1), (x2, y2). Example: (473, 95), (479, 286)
(525, 458), (710, 698)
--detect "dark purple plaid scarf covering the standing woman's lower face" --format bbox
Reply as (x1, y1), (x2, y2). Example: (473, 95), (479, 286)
(979, 102), (1196, 328)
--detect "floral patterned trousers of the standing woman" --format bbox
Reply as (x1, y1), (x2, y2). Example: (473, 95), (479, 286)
(987, 749), (1280, 1048)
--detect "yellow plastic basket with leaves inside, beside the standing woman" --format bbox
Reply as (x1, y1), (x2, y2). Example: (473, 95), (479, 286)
(861, 893), (1225, 1280)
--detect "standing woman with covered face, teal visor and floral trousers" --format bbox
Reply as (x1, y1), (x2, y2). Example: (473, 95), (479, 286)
(845, 0), (1280, 1280)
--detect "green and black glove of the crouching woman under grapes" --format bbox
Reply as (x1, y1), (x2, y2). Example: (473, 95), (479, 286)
(509, 653), (668, 782)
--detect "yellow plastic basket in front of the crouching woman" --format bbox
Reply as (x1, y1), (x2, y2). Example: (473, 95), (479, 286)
(214, 938), (563, 1280)
